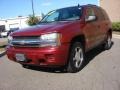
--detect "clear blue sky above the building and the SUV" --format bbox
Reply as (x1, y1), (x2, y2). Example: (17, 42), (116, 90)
(0, 0), (98, 19)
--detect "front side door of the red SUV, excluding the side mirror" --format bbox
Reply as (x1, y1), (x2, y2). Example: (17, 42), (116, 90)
(83, 7), (99, 50)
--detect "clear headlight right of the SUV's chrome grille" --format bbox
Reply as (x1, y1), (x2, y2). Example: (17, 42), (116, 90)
(40, 33), (61, 47)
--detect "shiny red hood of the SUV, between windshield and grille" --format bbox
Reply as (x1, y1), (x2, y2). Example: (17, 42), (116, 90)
(12, 21), (73, 36)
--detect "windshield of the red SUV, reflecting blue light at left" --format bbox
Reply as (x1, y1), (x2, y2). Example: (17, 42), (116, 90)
(41, 7), (82, 22)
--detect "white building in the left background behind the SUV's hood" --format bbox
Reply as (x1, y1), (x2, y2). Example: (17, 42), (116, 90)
(0, 17), (28, 31)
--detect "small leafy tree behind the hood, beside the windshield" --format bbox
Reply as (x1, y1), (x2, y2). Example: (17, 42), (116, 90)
(27, 15), (40, 26)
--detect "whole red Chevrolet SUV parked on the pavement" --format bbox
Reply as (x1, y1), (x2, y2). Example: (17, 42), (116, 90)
(7, 5), (112, 72)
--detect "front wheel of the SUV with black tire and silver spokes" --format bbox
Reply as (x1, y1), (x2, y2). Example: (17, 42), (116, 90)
(67, 42), (84, 73)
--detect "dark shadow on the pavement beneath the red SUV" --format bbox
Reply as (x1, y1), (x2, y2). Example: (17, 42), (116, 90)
(23, 42), (114, 73)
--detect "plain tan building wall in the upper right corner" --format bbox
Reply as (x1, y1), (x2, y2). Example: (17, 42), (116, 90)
(100, 0), (120, 22)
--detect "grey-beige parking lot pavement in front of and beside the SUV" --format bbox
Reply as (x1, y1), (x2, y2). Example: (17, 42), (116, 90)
(0, 38), (120, 90)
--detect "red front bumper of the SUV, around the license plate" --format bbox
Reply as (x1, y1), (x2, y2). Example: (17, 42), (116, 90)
(7, 44), (69, 66)
